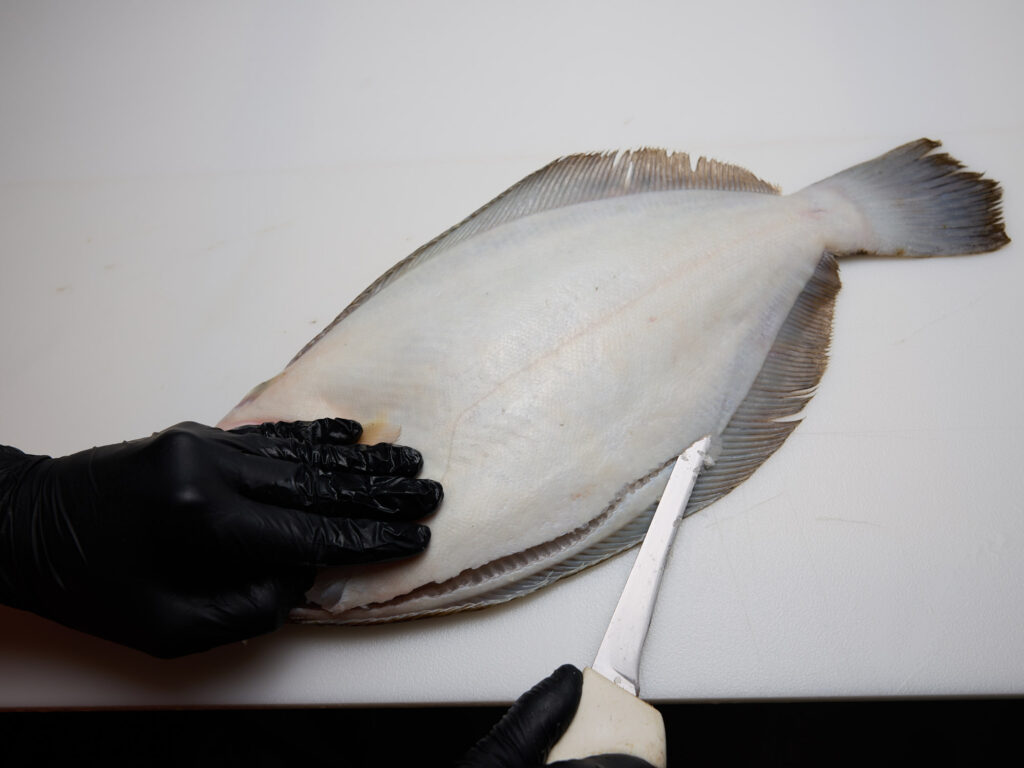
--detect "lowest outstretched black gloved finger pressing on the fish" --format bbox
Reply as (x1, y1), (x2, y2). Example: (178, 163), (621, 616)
(216, 503), (430, 565)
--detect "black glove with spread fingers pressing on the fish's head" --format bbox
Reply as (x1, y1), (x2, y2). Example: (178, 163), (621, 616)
(0, 419), (441, 657)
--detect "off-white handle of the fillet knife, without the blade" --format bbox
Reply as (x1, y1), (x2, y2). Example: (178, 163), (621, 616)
(548, 667), (668, 768)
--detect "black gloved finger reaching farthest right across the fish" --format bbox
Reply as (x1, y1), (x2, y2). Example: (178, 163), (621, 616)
(234, 457), (444, 520)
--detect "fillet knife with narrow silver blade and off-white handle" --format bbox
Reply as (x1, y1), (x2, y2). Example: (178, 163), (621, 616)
(548, 435), (711, 768)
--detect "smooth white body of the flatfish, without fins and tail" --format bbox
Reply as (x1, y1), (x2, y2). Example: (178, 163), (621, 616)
(222, 190), (827, 612)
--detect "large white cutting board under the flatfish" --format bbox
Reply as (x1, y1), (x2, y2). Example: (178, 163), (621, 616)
(0, 2), (1024, 708)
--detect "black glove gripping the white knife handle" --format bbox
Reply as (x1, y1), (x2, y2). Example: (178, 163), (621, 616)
(459, 664), (651, 768)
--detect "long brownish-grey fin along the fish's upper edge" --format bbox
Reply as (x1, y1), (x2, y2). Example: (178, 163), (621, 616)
(288, 148), (779, 365)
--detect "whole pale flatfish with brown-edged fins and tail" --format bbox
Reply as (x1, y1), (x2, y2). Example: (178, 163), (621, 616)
(220, 139), (1009, 624)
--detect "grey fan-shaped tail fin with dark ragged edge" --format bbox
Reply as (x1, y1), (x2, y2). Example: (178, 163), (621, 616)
(801, 138), (1010, 257)
